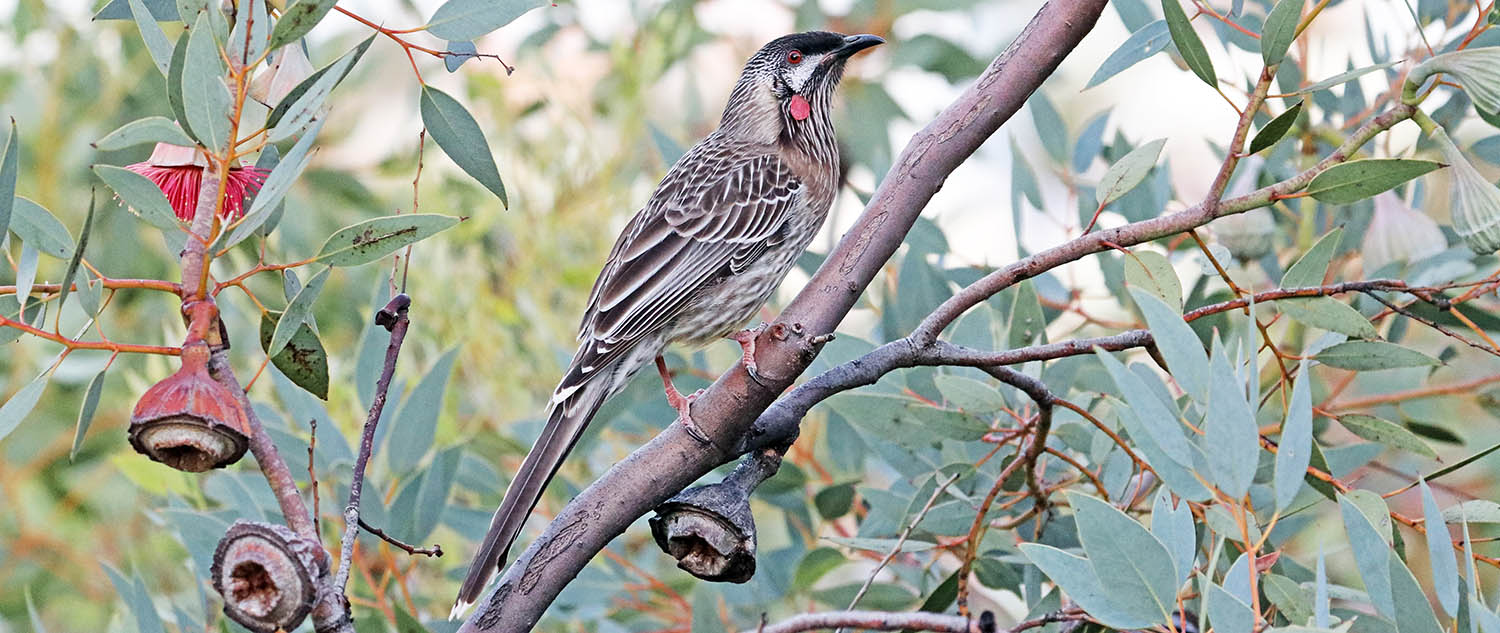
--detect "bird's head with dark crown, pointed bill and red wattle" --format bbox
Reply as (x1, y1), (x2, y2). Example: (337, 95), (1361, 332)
(722, 32), (885, 142)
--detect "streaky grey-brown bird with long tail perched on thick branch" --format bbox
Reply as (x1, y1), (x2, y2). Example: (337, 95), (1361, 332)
(452, 32), (885, 617)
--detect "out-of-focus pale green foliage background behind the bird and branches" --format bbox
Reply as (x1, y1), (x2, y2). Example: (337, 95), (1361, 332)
(0, 0), (1500, 632)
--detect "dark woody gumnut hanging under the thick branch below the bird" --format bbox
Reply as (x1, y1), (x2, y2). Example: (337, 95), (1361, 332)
(650, 450), (782, 582)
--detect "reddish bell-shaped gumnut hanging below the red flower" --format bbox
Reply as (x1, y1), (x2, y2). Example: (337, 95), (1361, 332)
(129, 341), (249, 473)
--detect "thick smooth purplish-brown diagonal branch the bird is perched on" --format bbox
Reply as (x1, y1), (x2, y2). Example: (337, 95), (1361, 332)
(461, 0), (1106, 632)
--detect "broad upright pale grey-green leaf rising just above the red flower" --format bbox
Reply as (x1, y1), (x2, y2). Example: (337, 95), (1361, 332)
(182, 12), (231, 152)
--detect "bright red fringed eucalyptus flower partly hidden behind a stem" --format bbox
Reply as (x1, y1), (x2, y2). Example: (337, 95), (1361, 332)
(126, 143), (267, 222)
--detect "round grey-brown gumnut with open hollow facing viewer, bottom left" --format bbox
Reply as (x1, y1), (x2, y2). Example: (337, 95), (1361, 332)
(210, 521), (329, 633)
